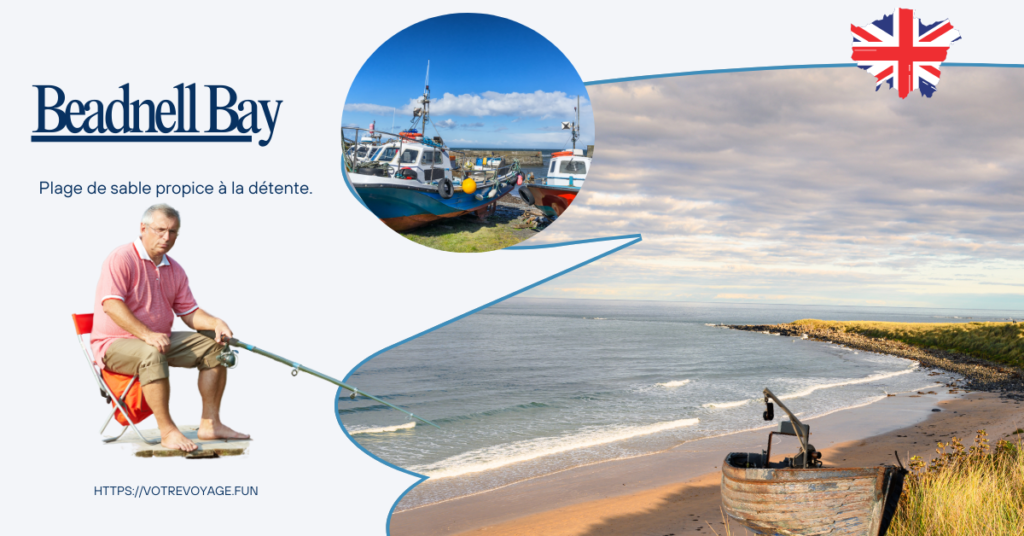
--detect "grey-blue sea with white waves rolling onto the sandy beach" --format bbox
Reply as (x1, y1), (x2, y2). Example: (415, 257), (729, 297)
(338, 298), (1024, 509)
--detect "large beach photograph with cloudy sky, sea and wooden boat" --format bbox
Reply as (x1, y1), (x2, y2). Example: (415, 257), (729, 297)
(337, 67), (1024, 536)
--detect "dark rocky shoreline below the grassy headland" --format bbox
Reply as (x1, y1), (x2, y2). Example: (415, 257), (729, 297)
(717, 324), (1024, 401)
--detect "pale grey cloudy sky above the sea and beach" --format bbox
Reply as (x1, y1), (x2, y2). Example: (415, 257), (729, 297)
(529, 67), (1024, 310)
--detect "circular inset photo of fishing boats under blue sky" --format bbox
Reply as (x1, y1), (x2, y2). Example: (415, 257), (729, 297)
(341, 13), (594, 252)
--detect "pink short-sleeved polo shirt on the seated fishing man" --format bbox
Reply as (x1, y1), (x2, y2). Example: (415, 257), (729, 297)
(90, 239), (199, 367)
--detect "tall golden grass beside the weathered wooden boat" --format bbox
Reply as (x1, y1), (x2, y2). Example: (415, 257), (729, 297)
(887, 430), (1024, 536)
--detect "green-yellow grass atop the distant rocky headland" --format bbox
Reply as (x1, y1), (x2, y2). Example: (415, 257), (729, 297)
(793, 319), (1024, 368)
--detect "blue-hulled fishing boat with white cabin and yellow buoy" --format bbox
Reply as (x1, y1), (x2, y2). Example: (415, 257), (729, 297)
(342, 63), (523, 232)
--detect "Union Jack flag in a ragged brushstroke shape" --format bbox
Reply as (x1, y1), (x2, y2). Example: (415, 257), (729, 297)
(850, 8), (961, 98)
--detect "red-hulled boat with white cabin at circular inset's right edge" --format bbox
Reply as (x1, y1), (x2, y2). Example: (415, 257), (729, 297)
(519, 97), (591, 217)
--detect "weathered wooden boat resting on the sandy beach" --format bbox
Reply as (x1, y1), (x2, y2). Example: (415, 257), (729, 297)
(722, 388), (907, 536)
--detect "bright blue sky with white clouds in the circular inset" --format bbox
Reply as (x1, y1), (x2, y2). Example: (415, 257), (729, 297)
(342, 13), (594, 150)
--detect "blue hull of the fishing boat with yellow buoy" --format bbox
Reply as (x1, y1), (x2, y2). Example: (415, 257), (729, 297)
(353, 181), (515, 232)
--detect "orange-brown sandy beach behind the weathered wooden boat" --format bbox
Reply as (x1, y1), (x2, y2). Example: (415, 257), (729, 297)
(390, 387), (1024, 536)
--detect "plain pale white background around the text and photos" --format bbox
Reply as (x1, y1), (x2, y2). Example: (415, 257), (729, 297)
(0, 1), (1011, 535)
